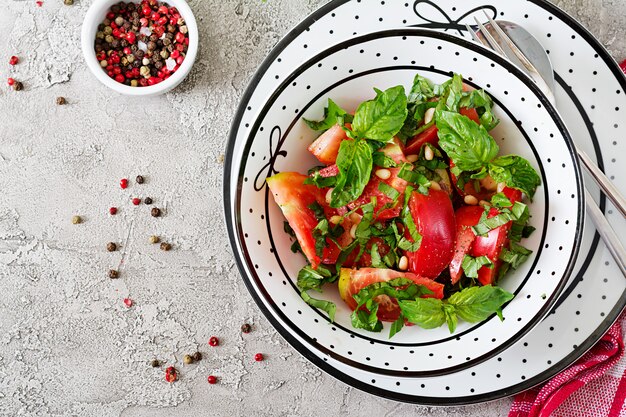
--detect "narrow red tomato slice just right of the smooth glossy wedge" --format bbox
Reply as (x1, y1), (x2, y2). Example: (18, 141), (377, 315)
(450, 206), (484, 285)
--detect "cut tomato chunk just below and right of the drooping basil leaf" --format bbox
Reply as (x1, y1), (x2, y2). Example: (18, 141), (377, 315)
(348, 168), (407, 220)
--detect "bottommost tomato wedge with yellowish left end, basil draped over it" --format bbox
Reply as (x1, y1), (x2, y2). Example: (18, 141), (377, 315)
(338, 268), (444, 321)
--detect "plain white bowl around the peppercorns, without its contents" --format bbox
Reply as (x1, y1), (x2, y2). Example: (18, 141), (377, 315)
(81, 0), (198, 97)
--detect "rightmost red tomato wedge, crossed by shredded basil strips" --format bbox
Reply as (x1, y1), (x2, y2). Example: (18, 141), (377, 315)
(471, 187), (522, 285)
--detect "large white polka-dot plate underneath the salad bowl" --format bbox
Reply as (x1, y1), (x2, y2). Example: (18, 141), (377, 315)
(224, 0), (626, 405)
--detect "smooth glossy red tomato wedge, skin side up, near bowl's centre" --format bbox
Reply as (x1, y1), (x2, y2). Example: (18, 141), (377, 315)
(405, 188), (456, 279)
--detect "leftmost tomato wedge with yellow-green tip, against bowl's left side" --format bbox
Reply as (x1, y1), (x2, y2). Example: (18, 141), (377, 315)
(267, 172), (352, 268)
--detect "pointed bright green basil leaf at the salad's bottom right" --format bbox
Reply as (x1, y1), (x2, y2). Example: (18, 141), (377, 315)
(448, 285), (514, 323)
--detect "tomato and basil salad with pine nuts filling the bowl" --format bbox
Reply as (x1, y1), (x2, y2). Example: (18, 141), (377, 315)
(267, 74), (540, 337)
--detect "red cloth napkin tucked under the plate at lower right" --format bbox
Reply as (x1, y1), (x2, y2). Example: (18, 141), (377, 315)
(509, 60), (626, 417)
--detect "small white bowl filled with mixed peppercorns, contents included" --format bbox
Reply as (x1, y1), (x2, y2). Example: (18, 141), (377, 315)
(82, 0), (198, 96)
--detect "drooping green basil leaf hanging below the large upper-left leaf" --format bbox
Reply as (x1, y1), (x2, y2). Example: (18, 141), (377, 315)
(330, 139), (373, 208)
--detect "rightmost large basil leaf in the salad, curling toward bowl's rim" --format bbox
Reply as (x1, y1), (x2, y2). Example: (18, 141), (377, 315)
(486, 155), (541, 200)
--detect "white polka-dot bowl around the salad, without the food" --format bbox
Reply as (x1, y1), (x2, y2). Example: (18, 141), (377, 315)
(232, 29), (583, 377)
